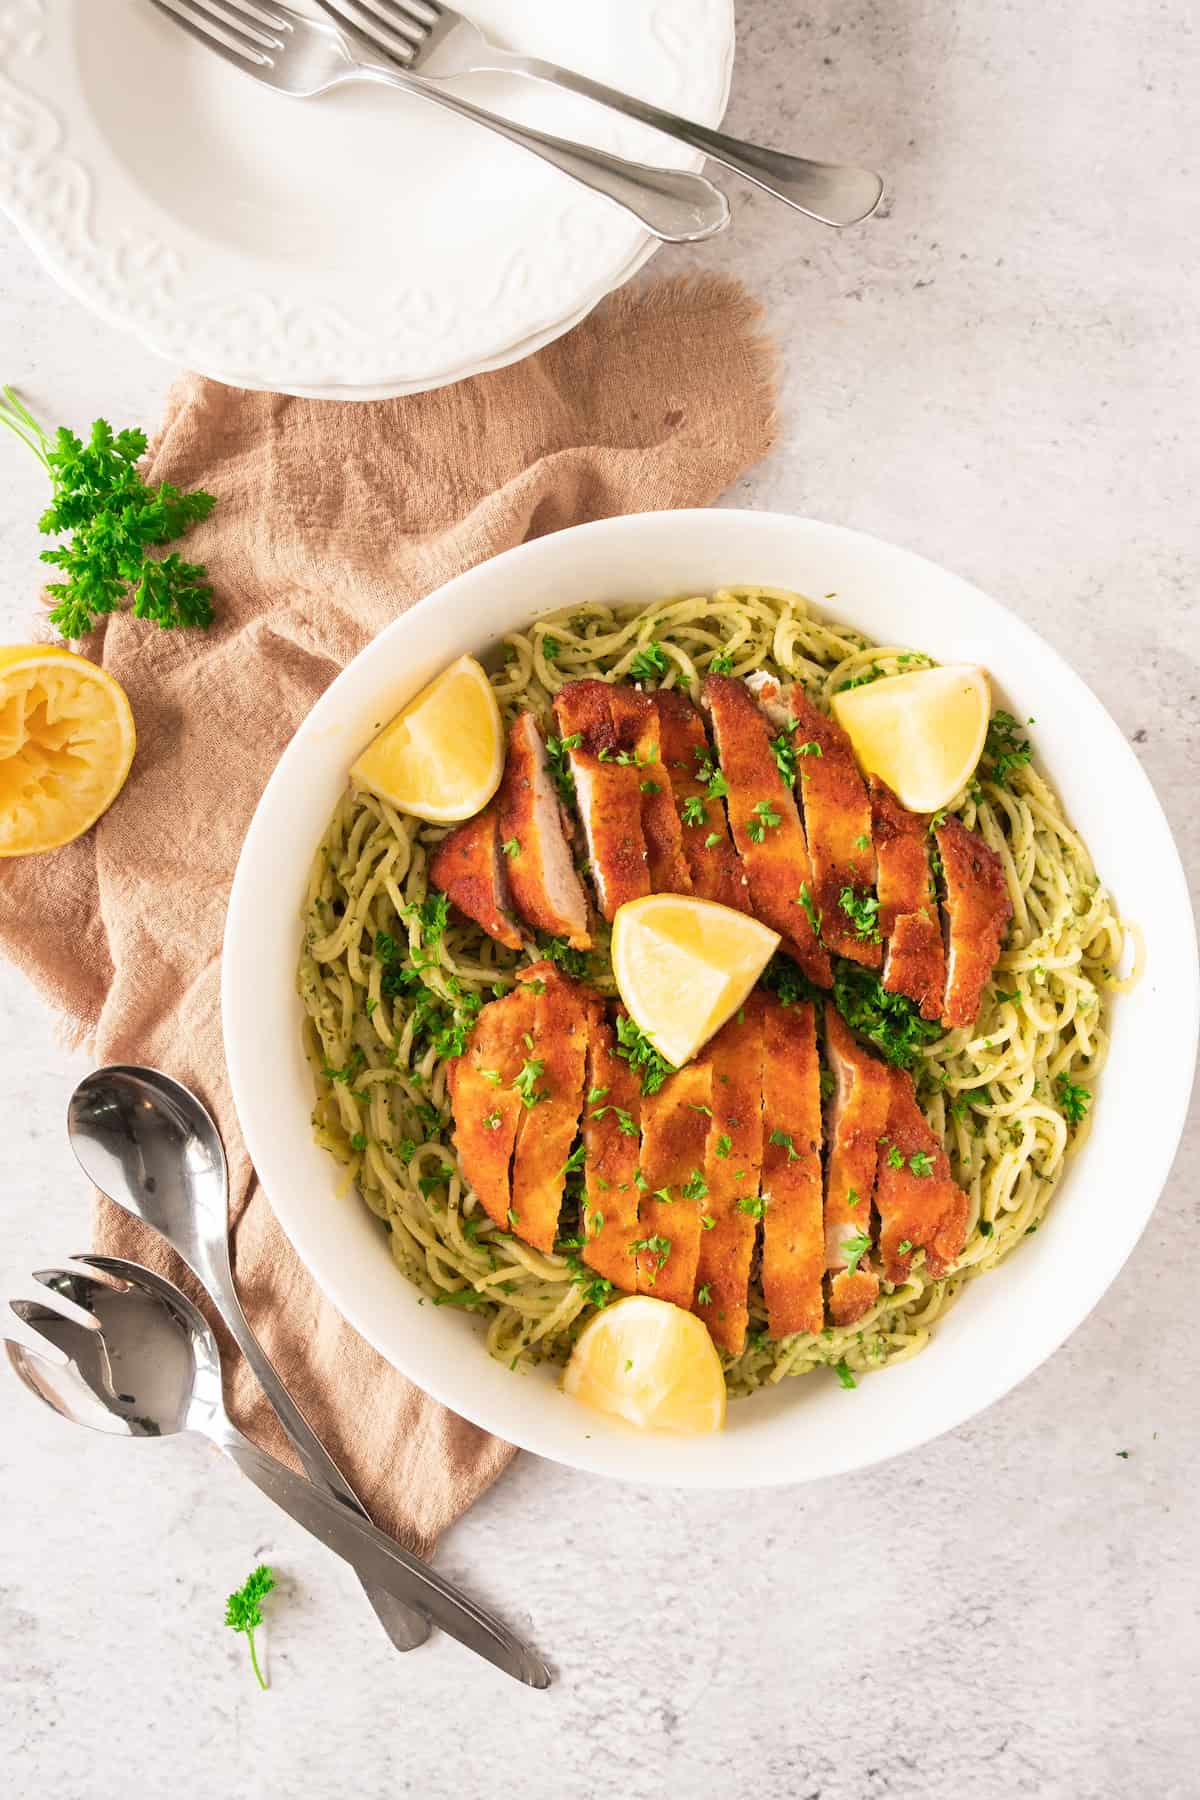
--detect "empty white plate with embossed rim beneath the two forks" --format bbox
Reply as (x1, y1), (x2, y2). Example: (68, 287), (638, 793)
(0, 0), (734, 398)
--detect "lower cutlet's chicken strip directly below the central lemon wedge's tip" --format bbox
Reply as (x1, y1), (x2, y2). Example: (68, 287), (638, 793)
(635, 1062), (712, 1307)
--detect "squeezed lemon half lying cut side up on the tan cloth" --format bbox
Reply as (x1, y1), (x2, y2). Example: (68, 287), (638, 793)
(0, 644), (137, 857)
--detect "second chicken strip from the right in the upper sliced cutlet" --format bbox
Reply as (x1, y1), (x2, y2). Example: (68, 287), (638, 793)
(871, 776), (946, 1019)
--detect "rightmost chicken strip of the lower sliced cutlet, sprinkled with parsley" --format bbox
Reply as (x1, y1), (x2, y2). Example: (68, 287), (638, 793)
(874, 1069), (968, 1282)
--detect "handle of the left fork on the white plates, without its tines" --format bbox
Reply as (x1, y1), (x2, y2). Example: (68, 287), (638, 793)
(356, 63), (729, 243)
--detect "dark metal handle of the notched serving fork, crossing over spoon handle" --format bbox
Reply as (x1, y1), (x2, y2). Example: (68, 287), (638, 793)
(212, 1426), (551, 1688)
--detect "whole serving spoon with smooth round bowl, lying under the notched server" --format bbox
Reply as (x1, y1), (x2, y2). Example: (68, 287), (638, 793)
(67, 1064), (430, 1651)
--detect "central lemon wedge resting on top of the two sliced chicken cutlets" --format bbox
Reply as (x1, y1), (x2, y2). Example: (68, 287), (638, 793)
(612, 895), (779, 1067)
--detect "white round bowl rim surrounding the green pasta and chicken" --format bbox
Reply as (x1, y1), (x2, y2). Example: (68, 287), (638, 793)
(221, 511), (1200, 1487)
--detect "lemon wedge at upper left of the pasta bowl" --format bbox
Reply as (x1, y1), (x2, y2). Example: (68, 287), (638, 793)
(351, 657), (504, 824)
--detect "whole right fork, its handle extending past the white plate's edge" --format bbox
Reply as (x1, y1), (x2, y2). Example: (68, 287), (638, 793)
(318, 0), (883, 225)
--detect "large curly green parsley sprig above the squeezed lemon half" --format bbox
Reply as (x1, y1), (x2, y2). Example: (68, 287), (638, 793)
(0, 387), (216, 639)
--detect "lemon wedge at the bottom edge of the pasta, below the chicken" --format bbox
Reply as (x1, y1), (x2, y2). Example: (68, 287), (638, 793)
(563, 1294), (725, 1433)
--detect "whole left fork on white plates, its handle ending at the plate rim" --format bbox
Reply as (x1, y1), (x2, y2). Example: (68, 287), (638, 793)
(153, 0), (729, 243)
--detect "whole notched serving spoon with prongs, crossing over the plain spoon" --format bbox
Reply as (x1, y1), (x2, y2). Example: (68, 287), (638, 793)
(5, 1256), (551, 1688)
